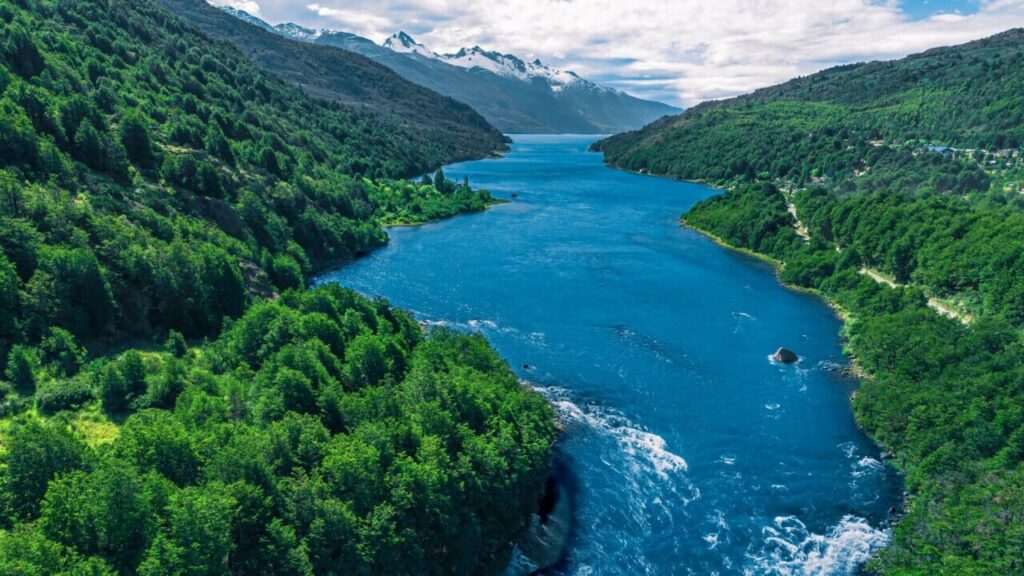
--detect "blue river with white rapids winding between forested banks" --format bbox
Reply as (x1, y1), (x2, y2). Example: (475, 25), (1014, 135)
(319, 136), (901, 575)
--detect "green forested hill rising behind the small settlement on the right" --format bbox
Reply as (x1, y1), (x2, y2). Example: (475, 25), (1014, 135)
(595, 30), (1024, 180)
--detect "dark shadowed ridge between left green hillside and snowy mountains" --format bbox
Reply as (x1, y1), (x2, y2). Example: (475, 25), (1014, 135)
(157, 0), (506, 163)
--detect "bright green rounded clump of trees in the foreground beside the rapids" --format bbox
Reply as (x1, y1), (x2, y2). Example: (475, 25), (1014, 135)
(0, 287), (555, 575)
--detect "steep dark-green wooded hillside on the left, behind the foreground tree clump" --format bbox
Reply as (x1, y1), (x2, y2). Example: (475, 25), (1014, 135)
(0, 0), (490, 354)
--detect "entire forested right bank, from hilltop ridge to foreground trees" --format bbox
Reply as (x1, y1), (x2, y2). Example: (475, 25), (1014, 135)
(598, 30), (1024, 575)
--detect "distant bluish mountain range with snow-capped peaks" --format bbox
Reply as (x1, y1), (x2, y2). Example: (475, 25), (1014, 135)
(222, 7), (681, 134)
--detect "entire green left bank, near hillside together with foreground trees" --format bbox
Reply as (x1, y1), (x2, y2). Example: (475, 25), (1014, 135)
(0, 0), (554, 576)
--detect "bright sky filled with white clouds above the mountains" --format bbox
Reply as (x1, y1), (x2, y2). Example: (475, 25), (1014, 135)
(211, 0), (1024, 106)
